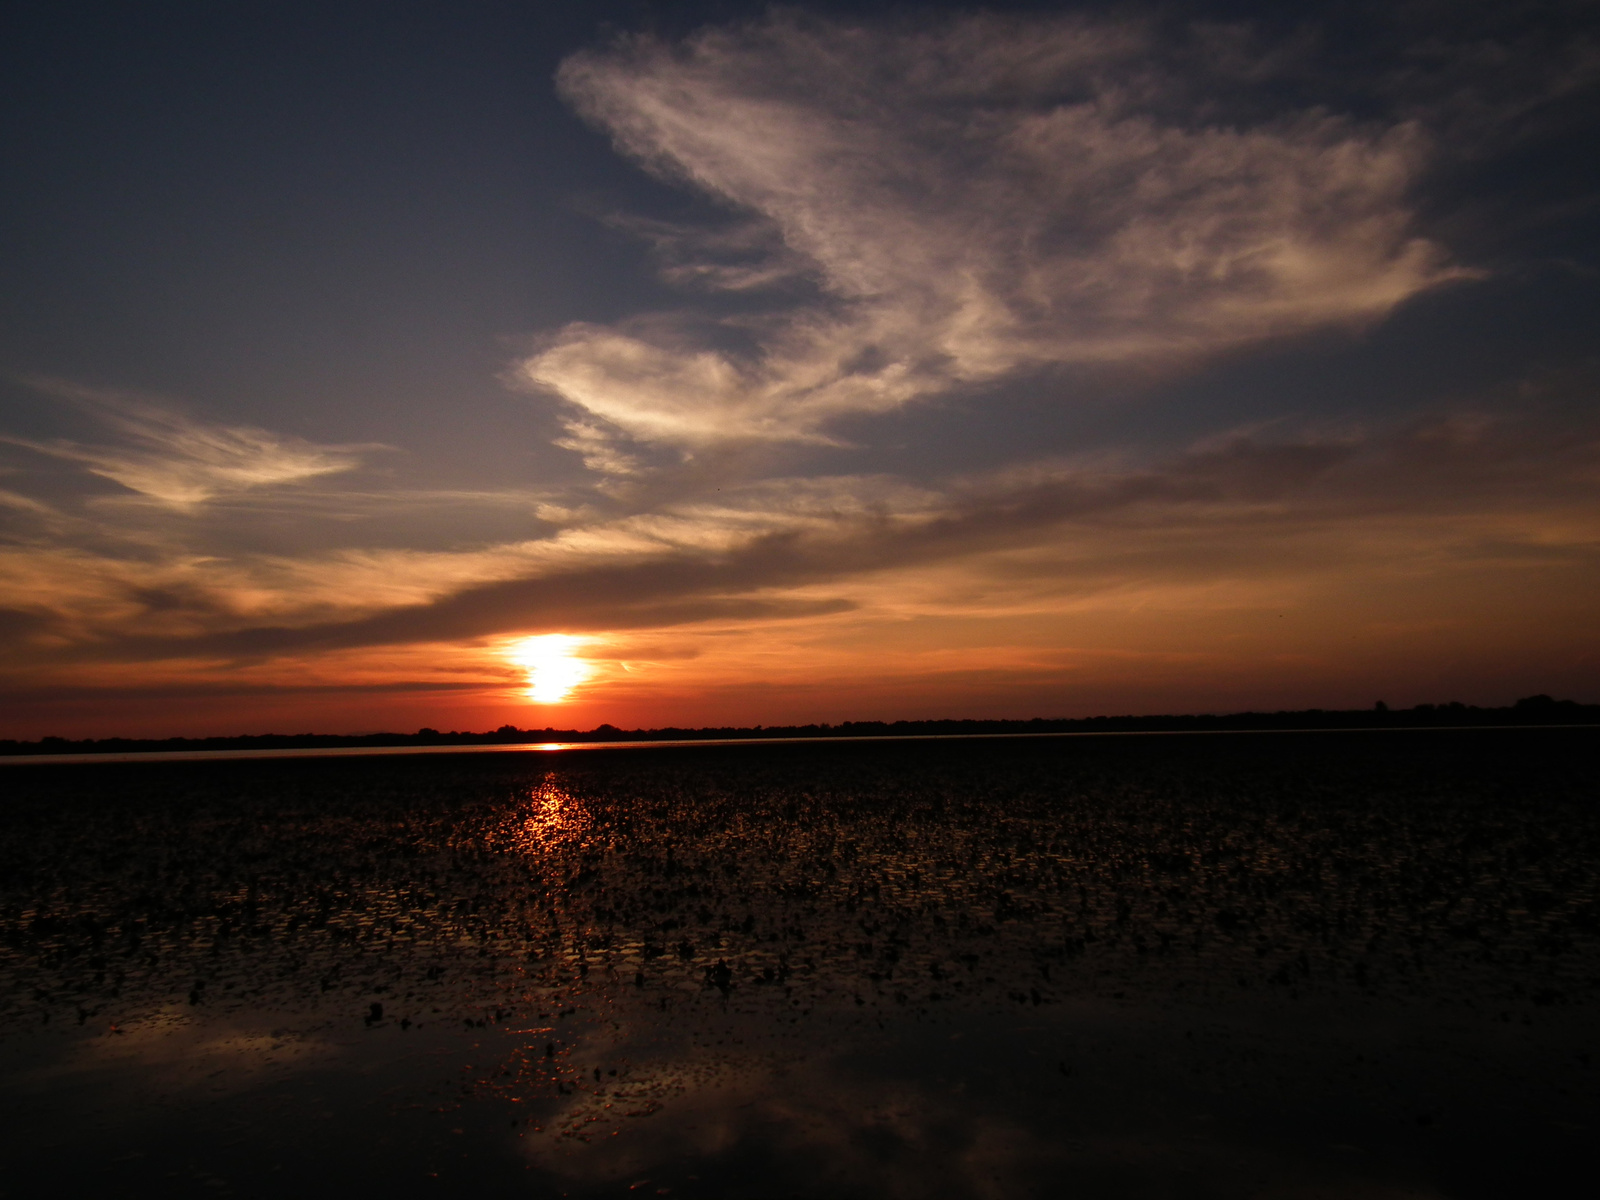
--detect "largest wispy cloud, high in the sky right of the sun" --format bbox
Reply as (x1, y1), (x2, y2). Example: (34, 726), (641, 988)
(518, 11), (1469, 474)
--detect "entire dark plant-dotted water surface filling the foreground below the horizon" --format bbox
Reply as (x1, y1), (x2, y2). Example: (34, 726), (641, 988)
(0, 730), (1600, 1197)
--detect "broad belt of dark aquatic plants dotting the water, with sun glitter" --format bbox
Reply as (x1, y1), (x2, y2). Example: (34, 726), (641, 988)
(0, 733), (1600, 1029)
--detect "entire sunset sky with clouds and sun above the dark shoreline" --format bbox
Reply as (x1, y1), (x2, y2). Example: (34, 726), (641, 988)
(0, 0), (1600, 738)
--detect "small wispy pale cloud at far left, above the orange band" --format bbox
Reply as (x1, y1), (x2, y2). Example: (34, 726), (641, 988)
(0, 381), (374, 509)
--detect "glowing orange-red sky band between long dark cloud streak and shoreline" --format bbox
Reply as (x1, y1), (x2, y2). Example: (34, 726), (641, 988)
(6, 534), (1600, 738)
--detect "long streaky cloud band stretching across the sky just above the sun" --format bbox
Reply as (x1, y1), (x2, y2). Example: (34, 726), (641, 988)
(14, 406), (1600, 672)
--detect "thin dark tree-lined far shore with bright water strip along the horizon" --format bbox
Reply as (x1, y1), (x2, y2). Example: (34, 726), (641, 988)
(0, 696), (1600, 760)
